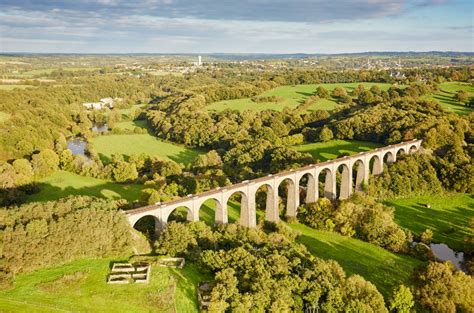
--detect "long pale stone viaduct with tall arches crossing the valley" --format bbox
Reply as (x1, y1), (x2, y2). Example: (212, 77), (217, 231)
(126, 140), (422, 231)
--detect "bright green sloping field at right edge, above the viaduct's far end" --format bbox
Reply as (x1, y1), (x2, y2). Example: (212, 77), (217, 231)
(429, 82), (474, 115)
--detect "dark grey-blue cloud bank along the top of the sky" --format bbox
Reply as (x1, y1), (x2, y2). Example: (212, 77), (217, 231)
(1, 0), (405, 23)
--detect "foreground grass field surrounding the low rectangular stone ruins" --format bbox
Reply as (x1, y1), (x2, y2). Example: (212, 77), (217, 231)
(0, 258), (207, 312)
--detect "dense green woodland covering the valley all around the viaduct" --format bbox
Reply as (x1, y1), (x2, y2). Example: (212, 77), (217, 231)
(0, 61), (474, 312)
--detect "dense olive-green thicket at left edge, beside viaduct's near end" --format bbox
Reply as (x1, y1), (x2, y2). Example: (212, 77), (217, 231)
(0, 197), (132, 286)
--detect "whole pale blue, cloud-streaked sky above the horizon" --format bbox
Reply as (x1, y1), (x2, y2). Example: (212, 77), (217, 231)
(0, 0), (474, 53)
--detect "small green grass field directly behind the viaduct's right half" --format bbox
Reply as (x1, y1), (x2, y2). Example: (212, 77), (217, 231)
(293, 140), (381, 161)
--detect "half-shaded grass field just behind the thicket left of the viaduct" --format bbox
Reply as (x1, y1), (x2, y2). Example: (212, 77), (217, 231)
(27, 171), (144, 202)
